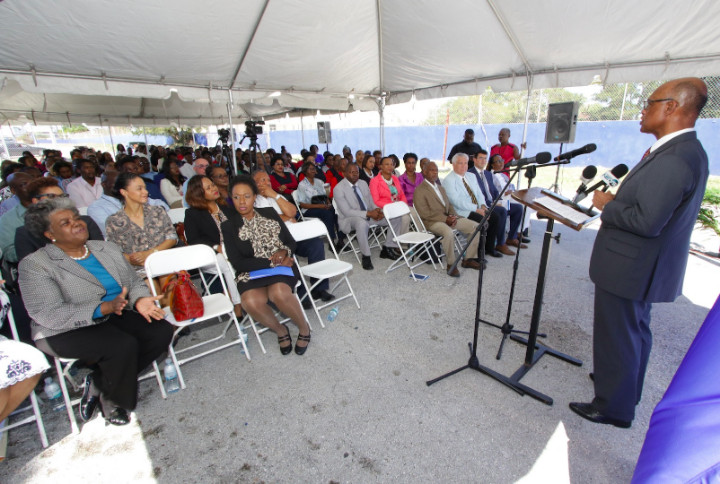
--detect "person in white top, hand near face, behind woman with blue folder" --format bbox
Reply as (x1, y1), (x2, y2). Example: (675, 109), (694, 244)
(253, 171), (335, 309)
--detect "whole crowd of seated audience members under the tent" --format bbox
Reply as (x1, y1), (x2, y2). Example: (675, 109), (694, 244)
(0, 138), (536, 436)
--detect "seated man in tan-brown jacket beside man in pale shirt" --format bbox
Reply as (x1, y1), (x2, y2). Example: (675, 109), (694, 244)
(415, 161), (480, 277)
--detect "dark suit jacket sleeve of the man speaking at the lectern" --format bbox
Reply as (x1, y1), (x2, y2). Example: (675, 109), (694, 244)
(600, 154), (698, 237)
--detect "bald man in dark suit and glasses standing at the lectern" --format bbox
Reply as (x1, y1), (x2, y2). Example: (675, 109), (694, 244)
(570, 78), (708, 428)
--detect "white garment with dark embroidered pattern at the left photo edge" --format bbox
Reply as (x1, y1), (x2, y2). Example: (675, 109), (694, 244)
(0, 291), (50, 389)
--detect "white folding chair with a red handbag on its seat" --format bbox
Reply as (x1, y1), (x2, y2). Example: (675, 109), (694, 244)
(145, 245), (250, 398)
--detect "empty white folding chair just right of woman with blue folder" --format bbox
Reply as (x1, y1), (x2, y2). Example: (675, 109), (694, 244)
(288, 219), (360, 328)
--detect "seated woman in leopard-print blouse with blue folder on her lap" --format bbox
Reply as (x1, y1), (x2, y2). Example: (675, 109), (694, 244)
(221, 175), (310, 355)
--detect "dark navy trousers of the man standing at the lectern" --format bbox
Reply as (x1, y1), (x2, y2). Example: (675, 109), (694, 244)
(593, 286), (652, 421)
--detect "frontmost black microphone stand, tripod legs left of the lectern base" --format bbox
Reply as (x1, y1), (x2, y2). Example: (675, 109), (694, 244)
(426, 163), (548, 402)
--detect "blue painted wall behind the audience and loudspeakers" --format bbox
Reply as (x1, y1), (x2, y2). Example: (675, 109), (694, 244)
(266, 119), (720, 175)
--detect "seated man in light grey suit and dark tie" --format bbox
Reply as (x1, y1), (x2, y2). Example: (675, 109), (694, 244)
(333, 163), (402, 271)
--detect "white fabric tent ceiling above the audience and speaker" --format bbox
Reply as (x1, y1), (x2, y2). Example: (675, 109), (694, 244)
(0, 0), (720, 124)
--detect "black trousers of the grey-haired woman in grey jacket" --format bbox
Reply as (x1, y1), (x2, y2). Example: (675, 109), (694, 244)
(35, 311), (173, 410)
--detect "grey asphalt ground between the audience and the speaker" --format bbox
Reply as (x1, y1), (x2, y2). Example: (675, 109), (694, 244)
(0, 220), (720, 483)
